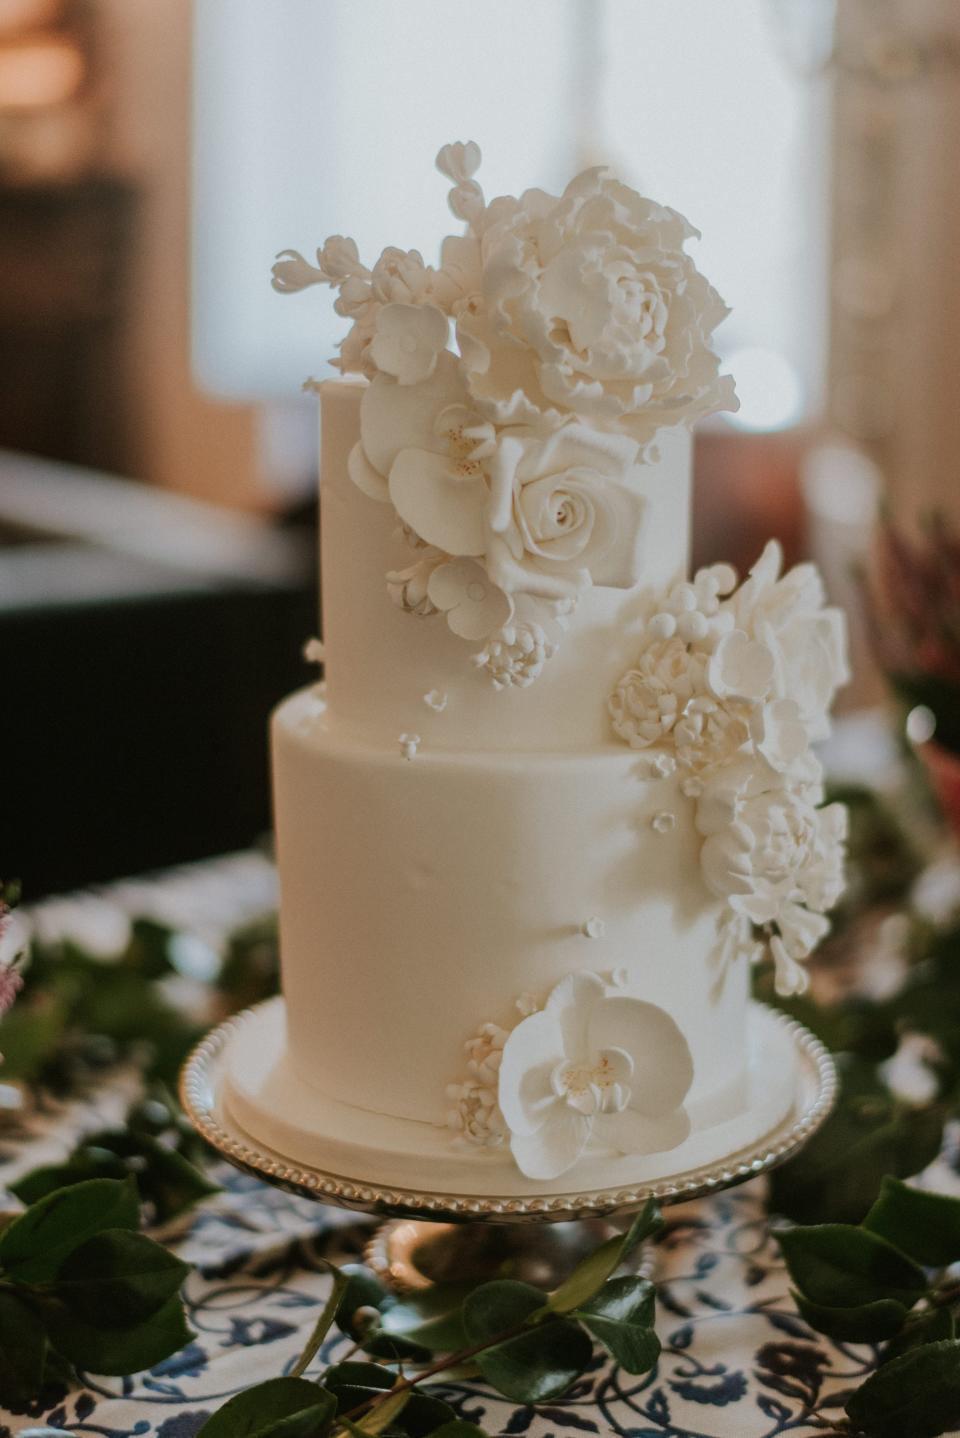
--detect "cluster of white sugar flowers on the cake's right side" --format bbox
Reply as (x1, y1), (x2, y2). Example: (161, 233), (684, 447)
(609, 542), (848, 994)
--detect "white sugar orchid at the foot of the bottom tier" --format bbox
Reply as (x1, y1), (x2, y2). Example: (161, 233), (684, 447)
(497, 974), (693, 1179)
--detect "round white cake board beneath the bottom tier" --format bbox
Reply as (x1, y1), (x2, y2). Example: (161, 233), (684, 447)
(218, 999), (818, 1206)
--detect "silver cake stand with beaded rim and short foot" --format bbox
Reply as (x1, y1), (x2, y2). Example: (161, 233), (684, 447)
(180, 1011), (836, 1288)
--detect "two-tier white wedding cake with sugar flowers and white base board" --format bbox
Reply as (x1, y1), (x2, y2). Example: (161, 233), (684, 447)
(226, 144), (845, 1195)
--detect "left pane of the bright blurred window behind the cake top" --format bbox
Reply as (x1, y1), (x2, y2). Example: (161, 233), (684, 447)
(193, 0), (577, 398)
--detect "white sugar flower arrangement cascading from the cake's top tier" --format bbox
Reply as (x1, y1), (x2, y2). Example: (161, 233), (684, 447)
(273, 142), (737, 689)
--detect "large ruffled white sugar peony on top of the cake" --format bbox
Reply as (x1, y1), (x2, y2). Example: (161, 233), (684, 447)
(457, 170), (737, 443)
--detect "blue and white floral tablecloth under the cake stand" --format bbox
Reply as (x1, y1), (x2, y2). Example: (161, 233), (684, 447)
(0, 1121), (871, 1438)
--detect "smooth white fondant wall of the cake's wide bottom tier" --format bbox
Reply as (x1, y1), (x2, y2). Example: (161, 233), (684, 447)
(273, 690), (749, 1144)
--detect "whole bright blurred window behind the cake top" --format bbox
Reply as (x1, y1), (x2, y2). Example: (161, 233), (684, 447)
(194, 0), (826, 429)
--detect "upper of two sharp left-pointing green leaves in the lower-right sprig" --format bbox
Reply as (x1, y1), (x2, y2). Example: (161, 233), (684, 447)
(773, 1224), (927, 1309)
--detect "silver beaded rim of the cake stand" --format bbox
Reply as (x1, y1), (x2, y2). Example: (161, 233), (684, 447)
(180, 1008), (838, 1222)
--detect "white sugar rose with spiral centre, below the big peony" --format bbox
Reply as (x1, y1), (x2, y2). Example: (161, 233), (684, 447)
(486, 424), (647, 600)
